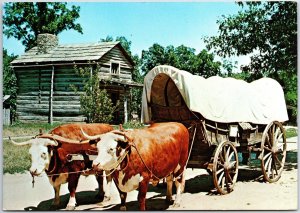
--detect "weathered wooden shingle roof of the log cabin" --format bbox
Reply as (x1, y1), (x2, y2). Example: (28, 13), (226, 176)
(11, 42), (133, 66)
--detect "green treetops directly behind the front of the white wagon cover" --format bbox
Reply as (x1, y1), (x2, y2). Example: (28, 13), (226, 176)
(141, 44), (221, 77)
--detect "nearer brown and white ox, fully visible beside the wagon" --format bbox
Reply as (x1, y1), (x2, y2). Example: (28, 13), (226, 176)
(83, 122), (189, 210)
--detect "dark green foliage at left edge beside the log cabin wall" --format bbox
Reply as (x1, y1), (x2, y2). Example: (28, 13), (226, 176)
(3, 49), (17, 120)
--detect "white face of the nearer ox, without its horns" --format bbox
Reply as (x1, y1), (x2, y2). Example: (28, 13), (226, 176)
(93, 132), (124, 170)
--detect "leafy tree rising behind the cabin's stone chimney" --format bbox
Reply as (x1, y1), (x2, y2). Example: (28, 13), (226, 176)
(3, 2), (82, 51)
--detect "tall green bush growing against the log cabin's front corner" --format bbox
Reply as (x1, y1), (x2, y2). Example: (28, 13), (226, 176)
(72, 65), (119, 123)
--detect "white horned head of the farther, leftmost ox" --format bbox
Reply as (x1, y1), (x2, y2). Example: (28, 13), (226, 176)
(10, 137), (58, 176)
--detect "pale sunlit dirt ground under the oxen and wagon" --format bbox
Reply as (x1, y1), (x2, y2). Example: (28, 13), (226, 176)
(2, 142), (298, 211)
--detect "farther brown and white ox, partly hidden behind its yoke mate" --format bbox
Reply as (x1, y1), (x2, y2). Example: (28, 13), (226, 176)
(12, 124), (113, 210)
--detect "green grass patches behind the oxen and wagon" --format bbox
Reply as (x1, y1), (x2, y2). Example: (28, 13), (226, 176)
(3, 122), (298, 174)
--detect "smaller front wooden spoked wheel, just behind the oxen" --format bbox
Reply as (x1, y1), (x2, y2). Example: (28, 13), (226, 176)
(212, 141), (238, 194)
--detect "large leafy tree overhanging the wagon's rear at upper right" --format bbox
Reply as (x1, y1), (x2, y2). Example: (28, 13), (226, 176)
(205, 1), (297, 123)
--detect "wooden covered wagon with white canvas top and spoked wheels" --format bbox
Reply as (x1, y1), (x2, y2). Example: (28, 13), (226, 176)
(142, 65), (288, 194)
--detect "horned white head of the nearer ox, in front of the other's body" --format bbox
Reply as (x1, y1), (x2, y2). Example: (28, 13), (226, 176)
(81, 130), (131, 171)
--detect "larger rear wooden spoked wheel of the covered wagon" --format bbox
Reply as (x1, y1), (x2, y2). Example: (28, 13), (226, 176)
(259, 121), (286, 183)
